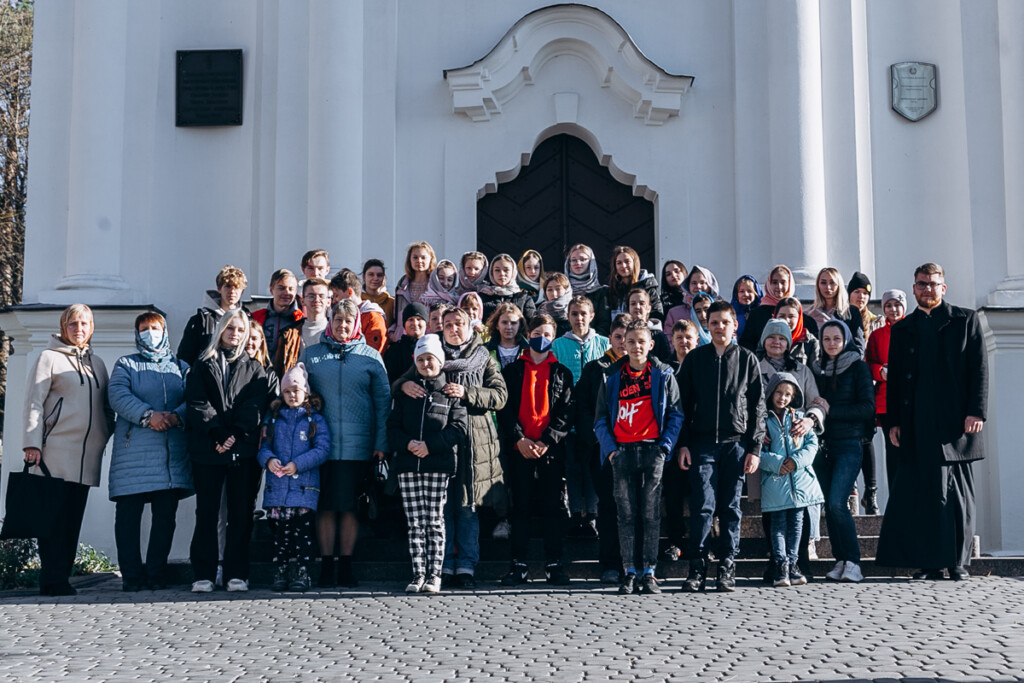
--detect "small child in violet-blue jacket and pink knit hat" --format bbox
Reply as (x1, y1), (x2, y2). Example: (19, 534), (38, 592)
(257, 362), (331, 592)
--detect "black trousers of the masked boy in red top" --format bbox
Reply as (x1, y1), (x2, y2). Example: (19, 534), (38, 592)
(506, 443), (569, 564)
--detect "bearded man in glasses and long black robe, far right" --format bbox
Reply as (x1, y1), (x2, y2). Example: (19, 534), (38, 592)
(877, 263), (988, 581)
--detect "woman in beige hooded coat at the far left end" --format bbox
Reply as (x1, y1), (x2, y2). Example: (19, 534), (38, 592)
(23, 303), (114, 596)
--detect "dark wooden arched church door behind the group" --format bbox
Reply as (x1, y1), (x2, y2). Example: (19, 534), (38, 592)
(476, 135), (655, 282)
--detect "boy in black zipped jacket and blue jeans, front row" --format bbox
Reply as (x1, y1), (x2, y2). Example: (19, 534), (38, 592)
(678, 301), (765, 592)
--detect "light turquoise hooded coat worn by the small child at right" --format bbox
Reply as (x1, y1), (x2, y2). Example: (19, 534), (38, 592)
(761, 405), (825, 512)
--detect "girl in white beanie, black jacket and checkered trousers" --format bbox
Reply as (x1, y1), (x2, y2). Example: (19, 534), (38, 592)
(387, 335), (469, 593)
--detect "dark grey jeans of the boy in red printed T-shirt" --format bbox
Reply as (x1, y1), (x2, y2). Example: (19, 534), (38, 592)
(611, 443), (665, 569)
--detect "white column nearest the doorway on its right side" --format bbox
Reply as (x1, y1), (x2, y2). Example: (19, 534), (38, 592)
(765, 0), (827, 296)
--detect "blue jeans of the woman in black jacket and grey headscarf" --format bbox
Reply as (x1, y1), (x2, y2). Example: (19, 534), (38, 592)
(821, 438), (863, 562)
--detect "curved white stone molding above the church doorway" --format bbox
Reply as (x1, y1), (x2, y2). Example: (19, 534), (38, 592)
(444, 4), (693, 126)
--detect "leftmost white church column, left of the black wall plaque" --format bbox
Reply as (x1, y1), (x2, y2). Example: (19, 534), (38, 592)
(46, 0), (131, 304)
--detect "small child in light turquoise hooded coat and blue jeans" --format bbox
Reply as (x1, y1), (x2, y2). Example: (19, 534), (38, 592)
(760, 373), (824, 587)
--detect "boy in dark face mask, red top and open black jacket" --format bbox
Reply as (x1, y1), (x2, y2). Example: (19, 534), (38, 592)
(498, 313), (572, 586)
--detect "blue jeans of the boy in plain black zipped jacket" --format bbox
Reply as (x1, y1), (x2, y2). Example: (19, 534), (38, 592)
(689, 442), (746, 560)
